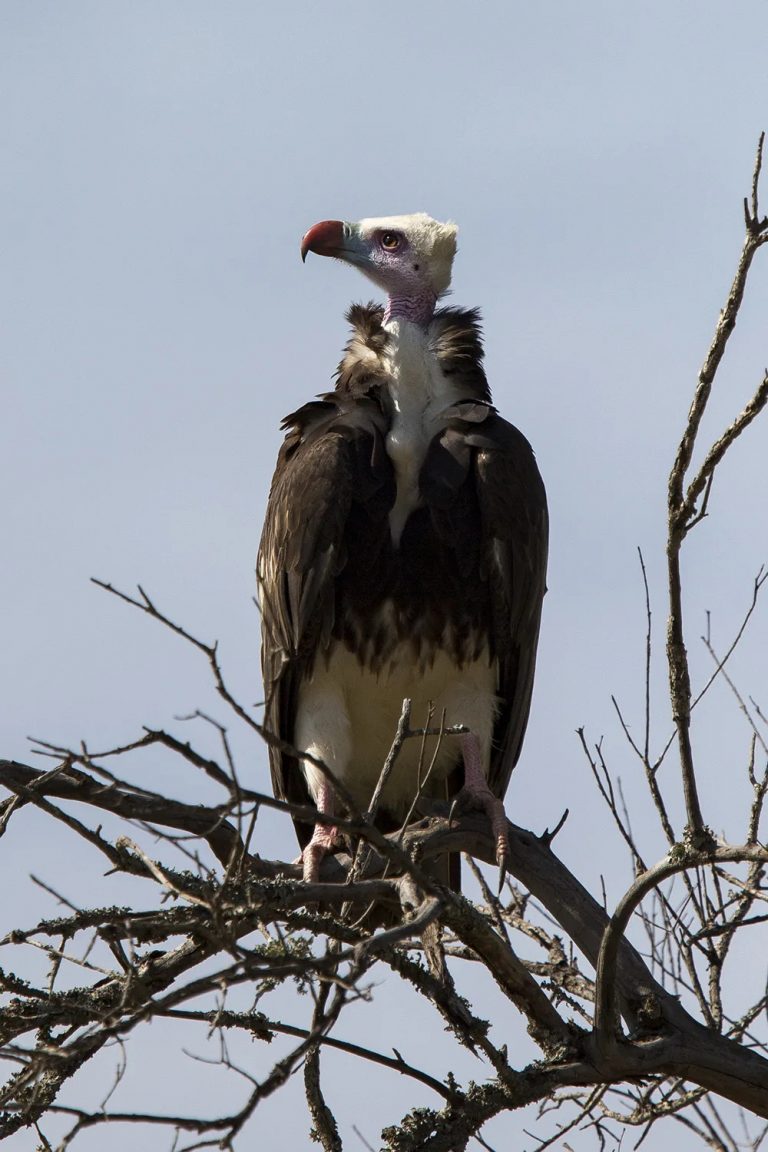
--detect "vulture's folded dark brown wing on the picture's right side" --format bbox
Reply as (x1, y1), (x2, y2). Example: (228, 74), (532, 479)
(421, 401), (549, 797)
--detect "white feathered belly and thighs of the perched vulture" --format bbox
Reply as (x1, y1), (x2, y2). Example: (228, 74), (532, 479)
(294, 644), (497, 817)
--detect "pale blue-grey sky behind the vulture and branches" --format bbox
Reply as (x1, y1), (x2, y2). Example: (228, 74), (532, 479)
(0, 0), (768, 1152)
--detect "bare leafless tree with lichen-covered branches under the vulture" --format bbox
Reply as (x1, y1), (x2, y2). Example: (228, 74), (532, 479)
(0, 137), (768, 1152)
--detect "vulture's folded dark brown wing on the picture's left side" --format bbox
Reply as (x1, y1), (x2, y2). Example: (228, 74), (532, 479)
(257, 394), (394, 844)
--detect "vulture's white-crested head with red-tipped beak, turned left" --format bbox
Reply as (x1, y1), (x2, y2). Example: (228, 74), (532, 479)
(302, 212), (458, 320)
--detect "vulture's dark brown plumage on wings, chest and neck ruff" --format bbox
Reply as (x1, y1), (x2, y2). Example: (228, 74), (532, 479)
(258, 299), (547, 880)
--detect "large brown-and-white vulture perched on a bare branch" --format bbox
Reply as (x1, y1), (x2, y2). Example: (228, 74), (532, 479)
(257, 213), (548, 887)
